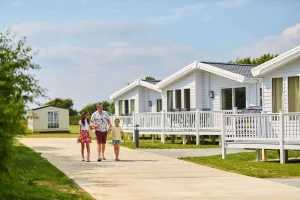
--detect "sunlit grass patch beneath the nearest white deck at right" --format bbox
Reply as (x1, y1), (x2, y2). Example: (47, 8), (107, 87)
(181, 150), (300, 178)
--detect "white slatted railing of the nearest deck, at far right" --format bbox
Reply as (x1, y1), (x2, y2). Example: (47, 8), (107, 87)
(224, 113), (300, 141)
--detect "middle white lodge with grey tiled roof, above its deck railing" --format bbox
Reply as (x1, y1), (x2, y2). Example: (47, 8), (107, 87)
(157, 62), (261, 111)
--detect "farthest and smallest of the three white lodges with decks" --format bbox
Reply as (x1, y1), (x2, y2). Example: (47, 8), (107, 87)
(109, 79), (162, 116)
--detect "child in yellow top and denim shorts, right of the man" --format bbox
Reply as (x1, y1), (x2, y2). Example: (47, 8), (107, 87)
(109, 119), (125, 161)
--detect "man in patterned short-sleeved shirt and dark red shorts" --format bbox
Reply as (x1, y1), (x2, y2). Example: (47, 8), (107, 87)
(91, 102), (111, 162)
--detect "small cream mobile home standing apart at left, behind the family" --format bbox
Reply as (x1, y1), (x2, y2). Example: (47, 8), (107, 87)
(28, 106), (69, 132)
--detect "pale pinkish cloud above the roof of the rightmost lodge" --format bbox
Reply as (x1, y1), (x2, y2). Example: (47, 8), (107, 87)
(235, 23), (300, 57)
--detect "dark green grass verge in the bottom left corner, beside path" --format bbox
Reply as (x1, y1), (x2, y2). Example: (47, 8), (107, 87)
(0, 142), (93, 200)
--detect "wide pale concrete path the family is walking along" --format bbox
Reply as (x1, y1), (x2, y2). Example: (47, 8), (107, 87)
(21, 138), (300, 200)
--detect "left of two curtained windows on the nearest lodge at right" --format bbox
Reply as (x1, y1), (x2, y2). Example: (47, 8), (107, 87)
(272, 78), (283, 113)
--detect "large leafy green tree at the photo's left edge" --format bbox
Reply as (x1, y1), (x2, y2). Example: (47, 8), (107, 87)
(0, 31), (45, 173)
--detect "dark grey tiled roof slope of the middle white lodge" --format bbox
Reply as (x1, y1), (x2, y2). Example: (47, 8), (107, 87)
(200, 61), (257, 78)
